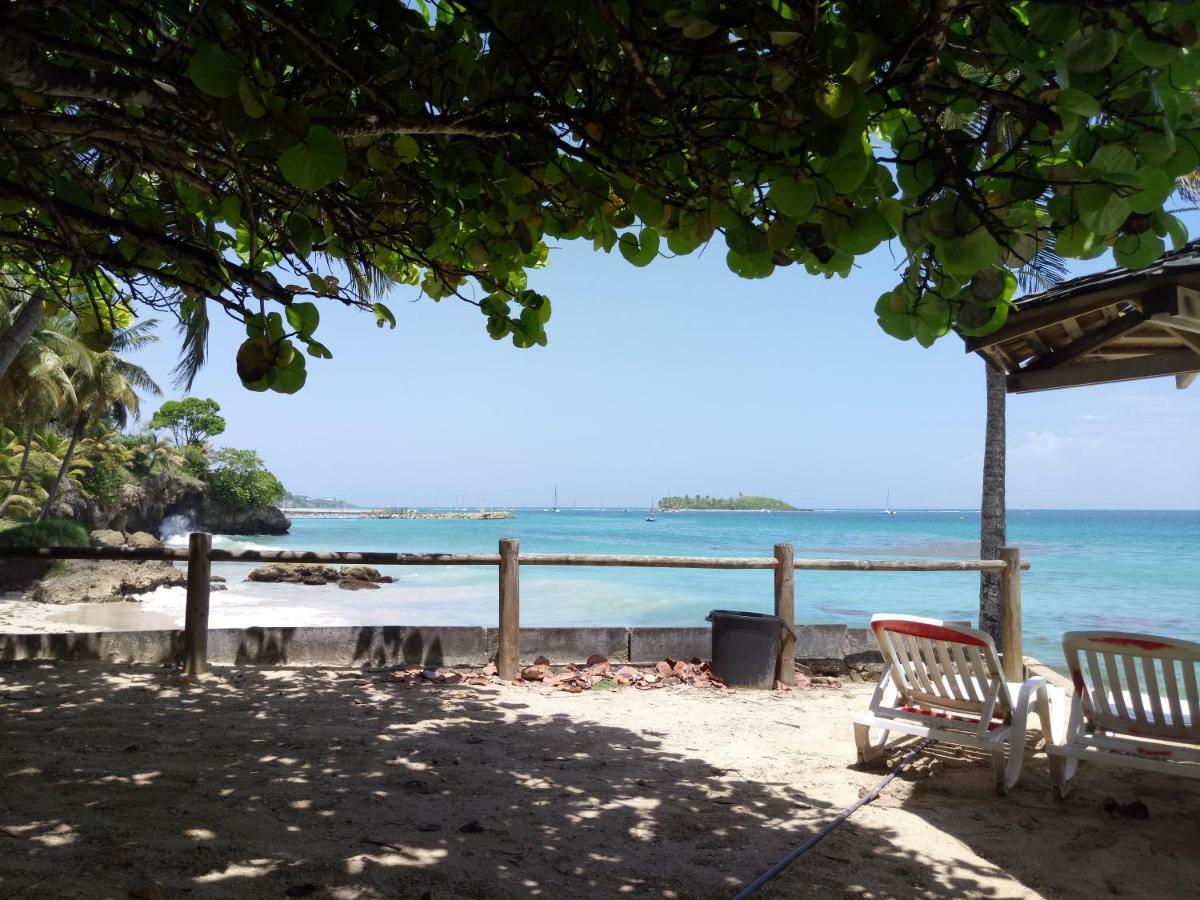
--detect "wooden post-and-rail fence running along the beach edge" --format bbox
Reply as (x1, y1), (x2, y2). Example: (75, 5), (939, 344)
(0, 540), (1030, 682)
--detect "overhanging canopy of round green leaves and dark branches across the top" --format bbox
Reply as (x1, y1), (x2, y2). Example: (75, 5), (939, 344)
(0, 0), (1200, 392)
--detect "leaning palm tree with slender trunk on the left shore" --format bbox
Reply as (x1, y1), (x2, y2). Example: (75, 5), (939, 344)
(38, 319), (162, 520)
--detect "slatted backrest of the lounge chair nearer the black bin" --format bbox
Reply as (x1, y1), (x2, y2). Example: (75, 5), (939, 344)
(871, 613), (1013, 724)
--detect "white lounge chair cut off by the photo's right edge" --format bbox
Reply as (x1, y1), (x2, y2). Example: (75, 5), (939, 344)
(1046, 631), (1200, 797)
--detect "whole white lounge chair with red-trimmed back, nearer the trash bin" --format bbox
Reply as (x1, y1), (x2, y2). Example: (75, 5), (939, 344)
(854, 614), (1052, 796)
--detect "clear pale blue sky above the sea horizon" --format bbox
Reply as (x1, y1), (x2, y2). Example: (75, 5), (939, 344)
(131, 234), (1200, 509)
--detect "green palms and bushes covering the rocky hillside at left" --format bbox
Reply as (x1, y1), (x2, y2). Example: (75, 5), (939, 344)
(0, 280), (282, 523)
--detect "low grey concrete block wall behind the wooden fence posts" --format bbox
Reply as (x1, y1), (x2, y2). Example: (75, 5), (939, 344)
(0, 625), (880, 668)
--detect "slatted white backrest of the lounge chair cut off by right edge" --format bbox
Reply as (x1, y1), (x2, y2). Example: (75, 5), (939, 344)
(1062, 631), (1200, 742)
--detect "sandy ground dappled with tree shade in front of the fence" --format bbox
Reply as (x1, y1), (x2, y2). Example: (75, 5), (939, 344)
(0, 662), (1200, 900)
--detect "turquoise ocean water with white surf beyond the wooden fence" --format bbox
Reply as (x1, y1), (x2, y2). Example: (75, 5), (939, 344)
(154, 509), (1200, 664)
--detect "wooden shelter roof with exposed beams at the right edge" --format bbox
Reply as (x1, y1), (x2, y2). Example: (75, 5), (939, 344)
(966, 240), (1200, 394)
